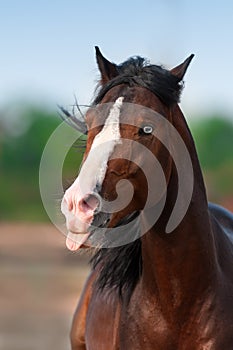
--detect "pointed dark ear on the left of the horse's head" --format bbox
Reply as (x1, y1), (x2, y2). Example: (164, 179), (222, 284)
(95, 46), (118, 85)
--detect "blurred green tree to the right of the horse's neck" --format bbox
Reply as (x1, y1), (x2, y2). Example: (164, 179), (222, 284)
(191, 115), (233, 204)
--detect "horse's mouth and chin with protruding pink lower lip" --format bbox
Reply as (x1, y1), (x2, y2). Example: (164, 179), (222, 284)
(66, 211), (140, 251)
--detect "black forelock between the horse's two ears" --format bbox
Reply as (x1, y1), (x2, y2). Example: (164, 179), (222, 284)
(94, 56), (183, 106)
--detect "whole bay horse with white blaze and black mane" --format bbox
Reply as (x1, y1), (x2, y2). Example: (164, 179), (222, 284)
(61, 47), (233, 350)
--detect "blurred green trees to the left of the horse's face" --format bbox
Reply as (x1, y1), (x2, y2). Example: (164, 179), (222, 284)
(0, 106), (81, 221)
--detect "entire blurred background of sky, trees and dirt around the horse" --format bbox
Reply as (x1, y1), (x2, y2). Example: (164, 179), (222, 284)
(0, 0), (233, 350)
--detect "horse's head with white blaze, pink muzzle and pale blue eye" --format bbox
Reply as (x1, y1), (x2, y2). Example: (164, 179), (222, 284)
(61, 48), (193, 250)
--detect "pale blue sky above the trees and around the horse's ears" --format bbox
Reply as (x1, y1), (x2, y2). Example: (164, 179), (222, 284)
(0, 0), (233, 118)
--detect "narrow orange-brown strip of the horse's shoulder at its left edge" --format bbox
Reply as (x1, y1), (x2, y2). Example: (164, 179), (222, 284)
(70, 271), (96, 350)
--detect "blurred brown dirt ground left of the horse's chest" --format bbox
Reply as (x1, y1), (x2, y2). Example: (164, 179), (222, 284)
(0, 223), (89, 350)
